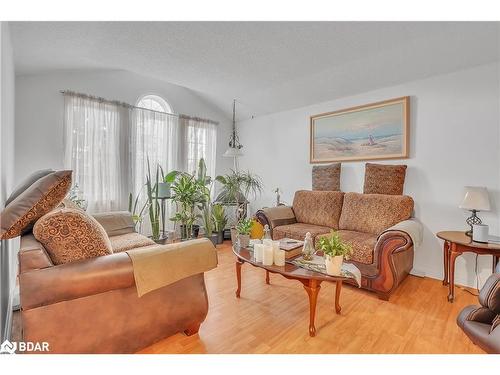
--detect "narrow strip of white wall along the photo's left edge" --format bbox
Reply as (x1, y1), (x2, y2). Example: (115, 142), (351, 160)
(0, 22), (19, 342)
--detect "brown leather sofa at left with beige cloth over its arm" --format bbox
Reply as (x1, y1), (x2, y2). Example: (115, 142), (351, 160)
(19, 213), (211, 353)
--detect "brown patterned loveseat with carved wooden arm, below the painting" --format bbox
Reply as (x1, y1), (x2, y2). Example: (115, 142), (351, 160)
(256, 190), (420, 300)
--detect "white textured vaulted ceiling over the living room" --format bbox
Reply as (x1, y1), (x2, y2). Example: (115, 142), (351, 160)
(11, 22), (499, 118)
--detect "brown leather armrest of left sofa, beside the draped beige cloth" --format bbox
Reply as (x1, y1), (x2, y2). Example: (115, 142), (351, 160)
(19, 253), (135, 310)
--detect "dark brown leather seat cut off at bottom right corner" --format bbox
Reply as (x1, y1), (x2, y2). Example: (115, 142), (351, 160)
(457, 263), (500, 354)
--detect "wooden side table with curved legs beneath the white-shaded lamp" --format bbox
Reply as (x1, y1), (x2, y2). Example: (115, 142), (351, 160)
(436, 231), (500, 302)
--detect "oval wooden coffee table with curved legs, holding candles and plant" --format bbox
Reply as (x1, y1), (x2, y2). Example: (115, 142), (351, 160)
(233, 246), (351, 337)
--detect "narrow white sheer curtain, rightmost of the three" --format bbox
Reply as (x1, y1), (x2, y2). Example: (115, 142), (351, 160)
(181, 117), (217, 178)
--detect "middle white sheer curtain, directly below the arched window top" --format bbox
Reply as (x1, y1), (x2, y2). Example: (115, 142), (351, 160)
(130, 108), (180, 229)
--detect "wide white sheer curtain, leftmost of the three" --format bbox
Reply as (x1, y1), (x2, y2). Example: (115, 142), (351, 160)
(64, 95), (128, 212)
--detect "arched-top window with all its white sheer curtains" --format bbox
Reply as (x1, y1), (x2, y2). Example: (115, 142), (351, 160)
(64, 93), (217, 217)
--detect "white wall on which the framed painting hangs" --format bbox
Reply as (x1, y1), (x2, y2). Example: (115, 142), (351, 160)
(239, 63), (500, 285)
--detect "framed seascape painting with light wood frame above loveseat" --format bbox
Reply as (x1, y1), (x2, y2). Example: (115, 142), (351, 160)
(310, 96), (410, 163)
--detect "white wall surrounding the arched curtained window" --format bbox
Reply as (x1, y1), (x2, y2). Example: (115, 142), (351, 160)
(15, 70), (231, 182)
